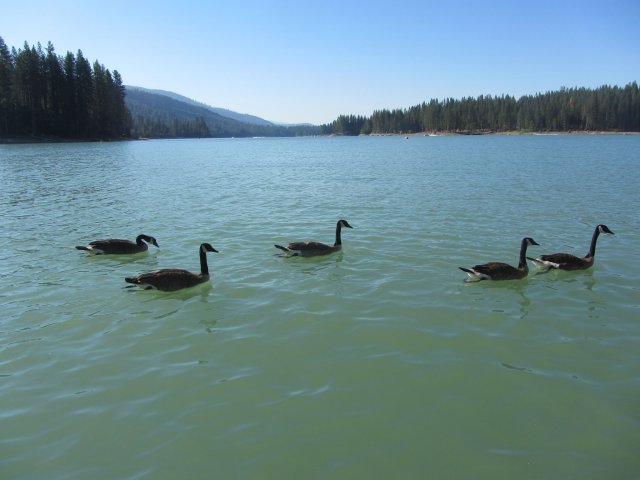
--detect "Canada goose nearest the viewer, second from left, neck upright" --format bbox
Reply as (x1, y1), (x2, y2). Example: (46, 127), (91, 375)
(124, 243), (218, 292)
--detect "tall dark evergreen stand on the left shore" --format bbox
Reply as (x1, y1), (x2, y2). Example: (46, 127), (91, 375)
(0, 37), (131, 139)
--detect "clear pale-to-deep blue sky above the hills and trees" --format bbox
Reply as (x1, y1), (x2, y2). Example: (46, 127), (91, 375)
(0, 0), (640, 124)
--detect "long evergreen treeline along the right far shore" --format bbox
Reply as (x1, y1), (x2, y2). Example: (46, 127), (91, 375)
(322, 82), (640, 135)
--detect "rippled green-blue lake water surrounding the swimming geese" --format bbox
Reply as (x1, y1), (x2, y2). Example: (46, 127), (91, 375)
(0, 136), (640, 479)
